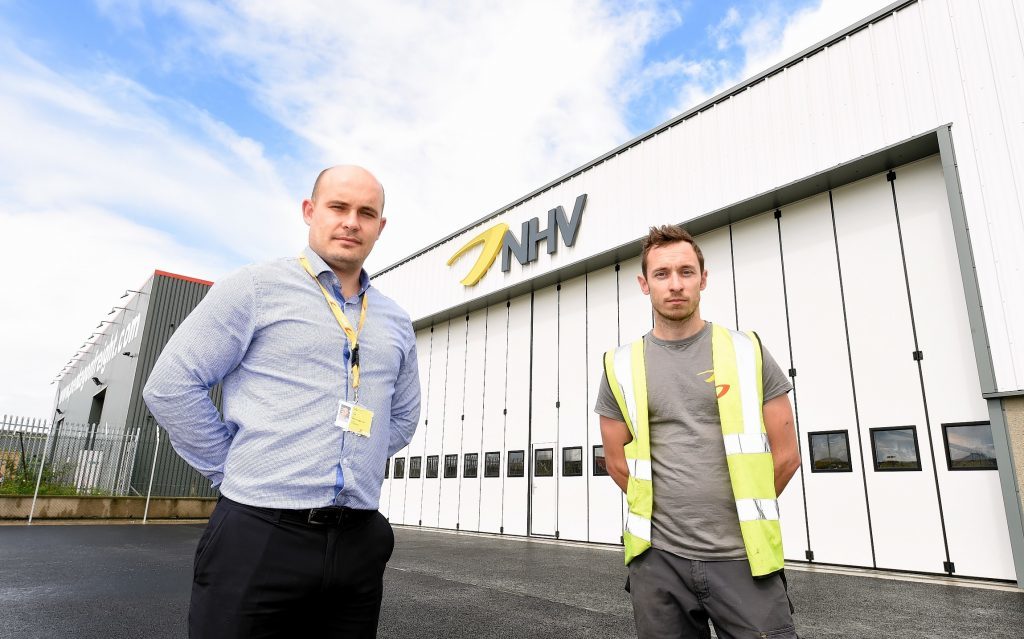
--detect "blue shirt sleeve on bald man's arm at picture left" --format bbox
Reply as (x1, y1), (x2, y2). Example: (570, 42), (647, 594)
(142, 269), (259, 485)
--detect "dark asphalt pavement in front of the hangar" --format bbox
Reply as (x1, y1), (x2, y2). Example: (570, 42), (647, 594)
(0, 523), (1024, 639)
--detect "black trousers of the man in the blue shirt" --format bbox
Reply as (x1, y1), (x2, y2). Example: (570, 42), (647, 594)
(188, 497), (394, 639)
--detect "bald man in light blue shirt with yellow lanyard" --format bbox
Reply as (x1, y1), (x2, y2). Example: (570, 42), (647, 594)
(144, 166), (420, 638)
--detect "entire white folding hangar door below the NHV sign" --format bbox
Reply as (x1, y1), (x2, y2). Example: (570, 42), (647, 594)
(390, 157), (1015, 580)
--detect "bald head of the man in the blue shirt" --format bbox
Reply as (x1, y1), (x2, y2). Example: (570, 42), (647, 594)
(302, 167), (387, 272)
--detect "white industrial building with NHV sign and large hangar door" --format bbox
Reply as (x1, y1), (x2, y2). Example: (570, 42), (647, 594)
(375, 0), (1024, 581)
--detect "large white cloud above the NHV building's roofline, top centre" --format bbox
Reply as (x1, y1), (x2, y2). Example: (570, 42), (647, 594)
(151, 0), (678, 270)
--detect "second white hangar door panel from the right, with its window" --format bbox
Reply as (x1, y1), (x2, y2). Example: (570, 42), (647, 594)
(833, 166), (942, 571)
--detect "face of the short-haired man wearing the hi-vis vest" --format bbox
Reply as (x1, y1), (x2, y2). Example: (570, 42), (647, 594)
(637, 242), (708, 322)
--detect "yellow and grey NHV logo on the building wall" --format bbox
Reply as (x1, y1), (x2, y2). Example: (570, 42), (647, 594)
(447, 194), (587, 287)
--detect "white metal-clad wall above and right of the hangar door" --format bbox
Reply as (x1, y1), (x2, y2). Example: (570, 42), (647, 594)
(378, 0), (1024, 391)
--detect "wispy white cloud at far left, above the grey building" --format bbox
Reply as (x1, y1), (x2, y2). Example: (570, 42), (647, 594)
(0, 45), (304, 416)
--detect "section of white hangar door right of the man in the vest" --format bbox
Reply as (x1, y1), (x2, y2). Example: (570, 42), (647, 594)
(716, 156), (1015, 580)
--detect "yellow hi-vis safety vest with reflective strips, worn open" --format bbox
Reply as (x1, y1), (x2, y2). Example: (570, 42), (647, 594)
(604, 324), (783, 577)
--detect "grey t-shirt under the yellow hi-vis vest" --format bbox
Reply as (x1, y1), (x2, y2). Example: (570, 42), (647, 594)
(594, 322), (793, 560)
